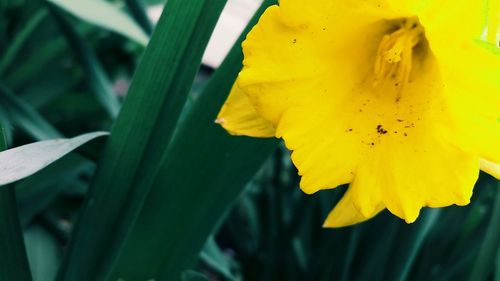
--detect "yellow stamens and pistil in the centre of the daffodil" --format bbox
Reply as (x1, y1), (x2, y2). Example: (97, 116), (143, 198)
(374, 17), (424, 92)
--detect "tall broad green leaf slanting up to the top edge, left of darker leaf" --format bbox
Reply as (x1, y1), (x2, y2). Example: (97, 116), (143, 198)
(58, 0), (229, 281)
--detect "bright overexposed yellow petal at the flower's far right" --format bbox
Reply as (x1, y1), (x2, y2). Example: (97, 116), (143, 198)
(423, 0), (500, 163)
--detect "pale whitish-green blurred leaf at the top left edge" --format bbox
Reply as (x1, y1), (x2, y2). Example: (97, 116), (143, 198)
(47, 0), (149, 46)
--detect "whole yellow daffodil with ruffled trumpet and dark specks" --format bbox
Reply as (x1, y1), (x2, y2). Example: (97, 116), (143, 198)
(217, 0), (500, 227)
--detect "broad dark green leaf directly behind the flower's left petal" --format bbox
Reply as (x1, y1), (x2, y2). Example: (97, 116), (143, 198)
(108, 0), (276, 281)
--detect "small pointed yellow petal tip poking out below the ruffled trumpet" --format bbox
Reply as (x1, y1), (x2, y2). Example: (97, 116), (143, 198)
(323, 186), (384, 227)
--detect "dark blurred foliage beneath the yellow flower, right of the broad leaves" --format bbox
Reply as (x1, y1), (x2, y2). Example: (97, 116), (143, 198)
(207, 148), (500, 281)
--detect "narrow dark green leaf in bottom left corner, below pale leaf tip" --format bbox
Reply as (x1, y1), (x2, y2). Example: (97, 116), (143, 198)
(0, 124), (32, 281)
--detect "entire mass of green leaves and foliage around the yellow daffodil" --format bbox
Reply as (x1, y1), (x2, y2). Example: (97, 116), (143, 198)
(0, 0), (500, 281)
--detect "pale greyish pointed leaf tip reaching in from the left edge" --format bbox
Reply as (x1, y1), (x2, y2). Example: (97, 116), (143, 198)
(0, 132), (108, 185)
